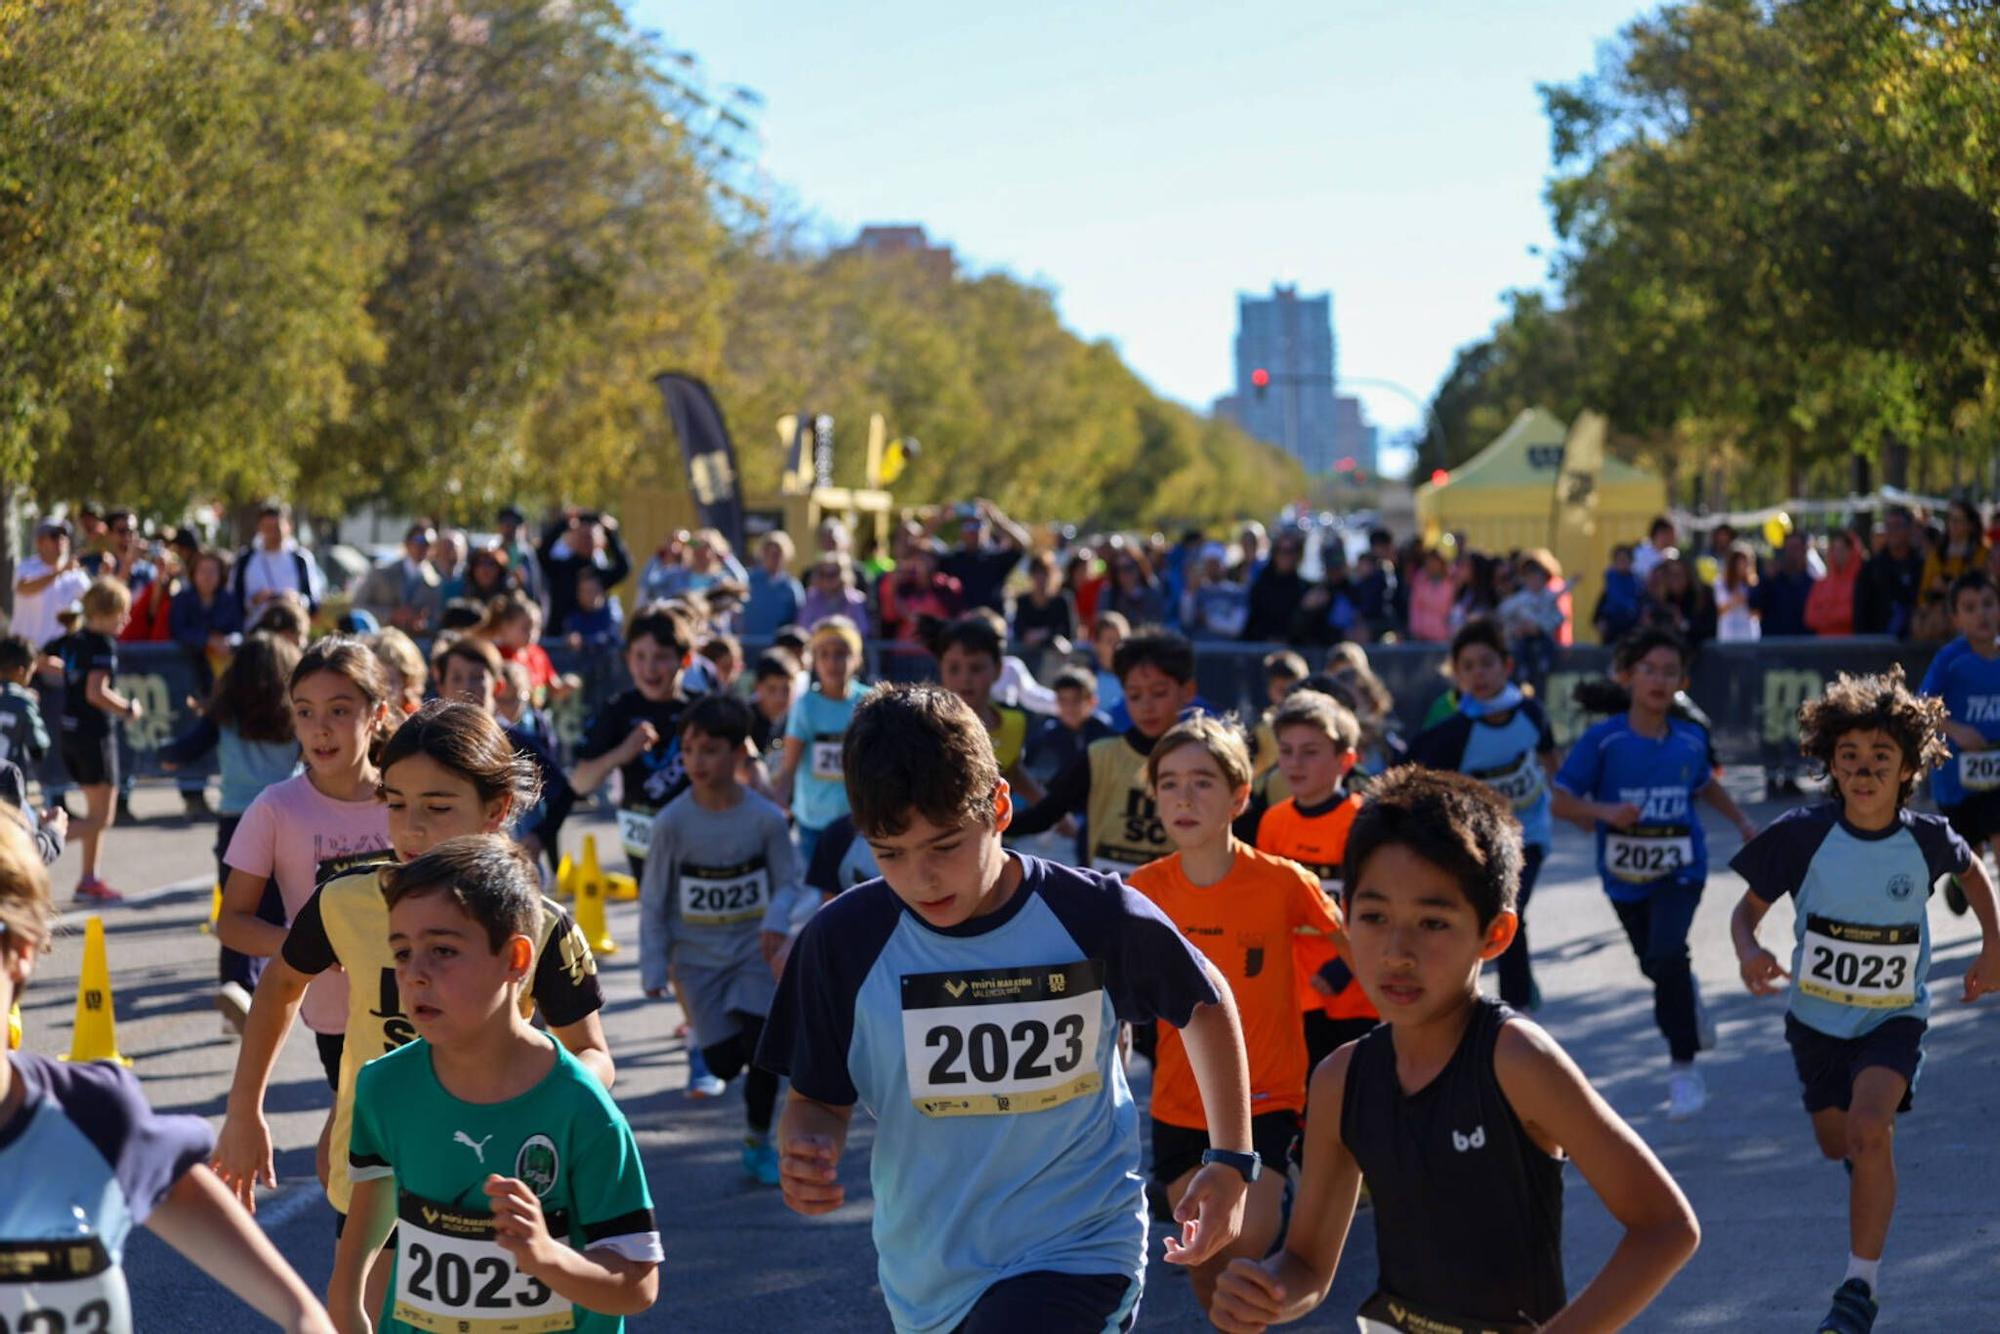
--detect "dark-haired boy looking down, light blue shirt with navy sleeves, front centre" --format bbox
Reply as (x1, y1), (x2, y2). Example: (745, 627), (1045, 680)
(758, 686), (1256, 1334)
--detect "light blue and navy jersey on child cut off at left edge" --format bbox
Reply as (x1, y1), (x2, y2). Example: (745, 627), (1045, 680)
(0, 1052), (214, 1334)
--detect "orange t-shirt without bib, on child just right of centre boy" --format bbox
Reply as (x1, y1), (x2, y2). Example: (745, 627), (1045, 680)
(1130, 848), (1340, 1130)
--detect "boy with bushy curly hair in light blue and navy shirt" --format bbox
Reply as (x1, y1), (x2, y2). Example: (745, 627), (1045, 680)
(1730, 668), (2000, 1334)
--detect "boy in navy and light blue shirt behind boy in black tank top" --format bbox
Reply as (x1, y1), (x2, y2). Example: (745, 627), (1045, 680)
(1410, 616), (1558, 1014)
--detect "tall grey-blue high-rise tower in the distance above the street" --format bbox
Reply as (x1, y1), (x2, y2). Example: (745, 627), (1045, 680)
(1216, 284), (1338, 474)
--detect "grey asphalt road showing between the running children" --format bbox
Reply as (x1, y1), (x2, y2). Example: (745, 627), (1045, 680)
(24, 788), (2000, 1334)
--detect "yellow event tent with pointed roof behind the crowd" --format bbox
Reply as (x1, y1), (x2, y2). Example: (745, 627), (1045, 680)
(1416, 408), (1666, 642)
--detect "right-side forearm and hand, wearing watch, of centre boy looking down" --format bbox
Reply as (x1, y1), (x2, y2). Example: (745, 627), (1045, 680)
(1166, 960), (1252, 1268)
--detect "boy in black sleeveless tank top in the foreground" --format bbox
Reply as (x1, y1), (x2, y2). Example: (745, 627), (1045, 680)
(1210, 766), (1700, 1334)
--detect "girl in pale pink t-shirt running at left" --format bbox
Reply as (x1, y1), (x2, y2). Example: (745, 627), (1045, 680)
(216, 638), (390, 1088)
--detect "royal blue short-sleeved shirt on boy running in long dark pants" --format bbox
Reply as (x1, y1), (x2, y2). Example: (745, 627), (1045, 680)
(1556, 714), (1710, 904)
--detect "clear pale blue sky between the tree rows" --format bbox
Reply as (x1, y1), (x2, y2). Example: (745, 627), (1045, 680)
(628, 0), (1652, 480)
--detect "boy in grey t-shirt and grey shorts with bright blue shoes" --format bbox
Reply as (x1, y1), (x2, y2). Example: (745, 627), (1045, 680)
(638, 694), (804, 1186)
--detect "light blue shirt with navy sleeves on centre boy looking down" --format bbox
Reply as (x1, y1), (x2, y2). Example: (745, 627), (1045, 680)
(758, 856), (1218, 1330)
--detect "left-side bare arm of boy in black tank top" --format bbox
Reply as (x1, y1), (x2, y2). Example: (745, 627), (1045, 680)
(1208, 1046), (1362, 1334)
